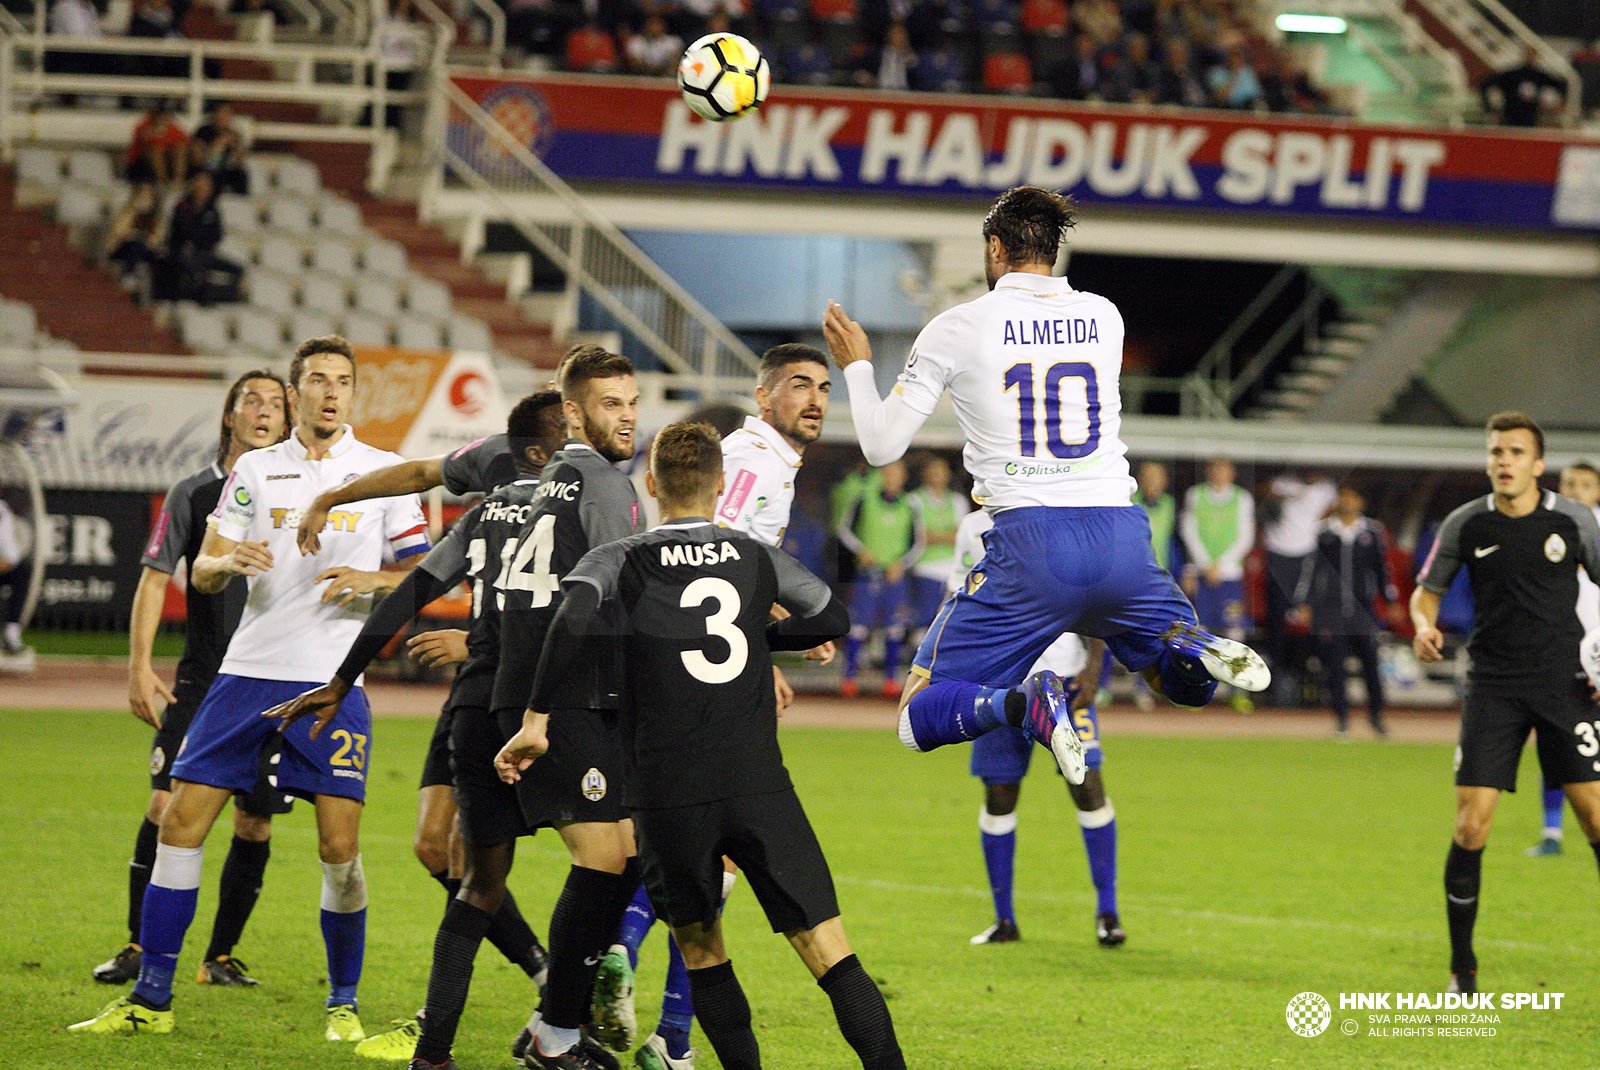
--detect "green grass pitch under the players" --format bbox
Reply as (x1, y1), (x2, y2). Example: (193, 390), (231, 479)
(0, 712), (1600, 1070)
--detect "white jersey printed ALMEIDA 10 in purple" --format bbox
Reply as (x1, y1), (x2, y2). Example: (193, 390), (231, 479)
(894, 272), (1134, 509)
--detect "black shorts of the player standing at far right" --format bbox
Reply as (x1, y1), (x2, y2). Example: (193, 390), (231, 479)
(1456, 680), (1600, 792)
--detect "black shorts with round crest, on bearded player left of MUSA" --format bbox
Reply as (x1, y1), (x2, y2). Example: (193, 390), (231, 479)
(499, 709), (627, 832)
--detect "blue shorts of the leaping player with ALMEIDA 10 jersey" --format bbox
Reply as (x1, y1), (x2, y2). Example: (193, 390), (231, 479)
(912, 505), (1195, 688)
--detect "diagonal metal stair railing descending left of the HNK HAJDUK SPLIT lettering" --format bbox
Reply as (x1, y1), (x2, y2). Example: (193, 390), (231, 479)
(432, 78), (760, 382)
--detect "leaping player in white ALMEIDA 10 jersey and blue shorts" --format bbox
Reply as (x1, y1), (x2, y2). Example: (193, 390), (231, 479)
(822, 186), (1270, 784)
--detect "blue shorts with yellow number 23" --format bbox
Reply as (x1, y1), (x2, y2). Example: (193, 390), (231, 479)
(173, 673), (373, 801)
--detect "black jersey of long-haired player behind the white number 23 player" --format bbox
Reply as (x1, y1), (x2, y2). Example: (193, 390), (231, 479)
(141, 462), (250, 685)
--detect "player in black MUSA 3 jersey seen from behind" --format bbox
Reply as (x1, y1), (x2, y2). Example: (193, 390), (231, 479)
(494, 422), (906, 1070)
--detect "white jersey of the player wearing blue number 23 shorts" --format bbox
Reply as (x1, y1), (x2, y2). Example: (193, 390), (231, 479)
(211, 424), (429, 683)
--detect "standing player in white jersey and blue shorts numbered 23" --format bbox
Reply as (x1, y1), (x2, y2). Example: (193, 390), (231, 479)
(72, 337), (429, 1041)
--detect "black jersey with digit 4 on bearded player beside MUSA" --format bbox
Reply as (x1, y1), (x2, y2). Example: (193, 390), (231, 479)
(491, 441), (640, 710)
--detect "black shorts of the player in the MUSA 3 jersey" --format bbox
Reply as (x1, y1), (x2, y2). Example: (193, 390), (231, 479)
(634, 789), (838, 932)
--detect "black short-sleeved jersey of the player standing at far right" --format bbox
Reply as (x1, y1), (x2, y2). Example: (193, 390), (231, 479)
(1418, 491), (1600, 686)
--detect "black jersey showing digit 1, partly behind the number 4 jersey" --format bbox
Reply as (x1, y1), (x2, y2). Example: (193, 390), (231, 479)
(418, 477), (539, 709)
